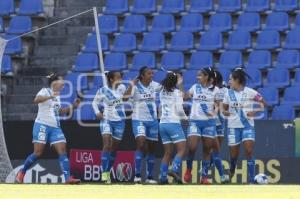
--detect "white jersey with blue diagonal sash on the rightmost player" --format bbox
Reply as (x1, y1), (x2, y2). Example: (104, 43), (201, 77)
(223, 87), (262, 128)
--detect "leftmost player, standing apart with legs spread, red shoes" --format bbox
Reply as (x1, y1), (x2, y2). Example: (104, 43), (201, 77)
(16, 73), (80, 184)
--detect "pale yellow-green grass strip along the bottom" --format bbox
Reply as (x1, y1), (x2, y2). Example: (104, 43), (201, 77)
(0, 184), (300, 199)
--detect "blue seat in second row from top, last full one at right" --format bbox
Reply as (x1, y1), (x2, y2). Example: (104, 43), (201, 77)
(265, 12), (289, 31)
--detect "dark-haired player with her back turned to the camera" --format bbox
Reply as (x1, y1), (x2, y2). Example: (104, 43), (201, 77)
(159, 72), (187, 184)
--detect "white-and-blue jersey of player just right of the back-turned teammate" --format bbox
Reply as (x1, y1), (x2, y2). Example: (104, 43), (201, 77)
(188, 84), (219, 120)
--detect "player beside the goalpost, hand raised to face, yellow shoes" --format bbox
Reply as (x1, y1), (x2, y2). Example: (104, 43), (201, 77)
(92, 71), (126, 183)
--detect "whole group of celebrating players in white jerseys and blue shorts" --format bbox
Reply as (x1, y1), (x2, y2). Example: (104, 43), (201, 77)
(16, 67), (265, 184)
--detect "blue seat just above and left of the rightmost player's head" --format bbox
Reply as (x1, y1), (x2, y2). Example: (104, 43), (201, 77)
(218, 51), (243, 69)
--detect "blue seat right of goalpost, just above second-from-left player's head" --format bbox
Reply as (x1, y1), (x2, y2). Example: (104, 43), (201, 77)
(104, 53), (127, 71)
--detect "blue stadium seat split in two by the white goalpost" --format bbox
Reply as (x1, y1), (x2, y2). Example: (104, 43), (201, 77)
(83, 33), (109, 53)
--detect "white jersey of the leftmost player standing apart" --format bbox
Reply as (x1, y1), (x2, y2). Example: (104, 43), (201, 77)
(35, 88), (61, 127)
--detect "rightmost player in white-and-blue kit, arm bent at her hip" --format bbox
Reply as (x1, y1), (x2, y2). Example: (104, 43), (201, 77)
(223, 68), (265, 183)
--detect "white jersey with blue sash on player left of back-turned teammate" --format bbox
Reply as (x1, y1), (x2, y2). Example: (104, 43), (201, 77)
(132, 81), (161, 121)
